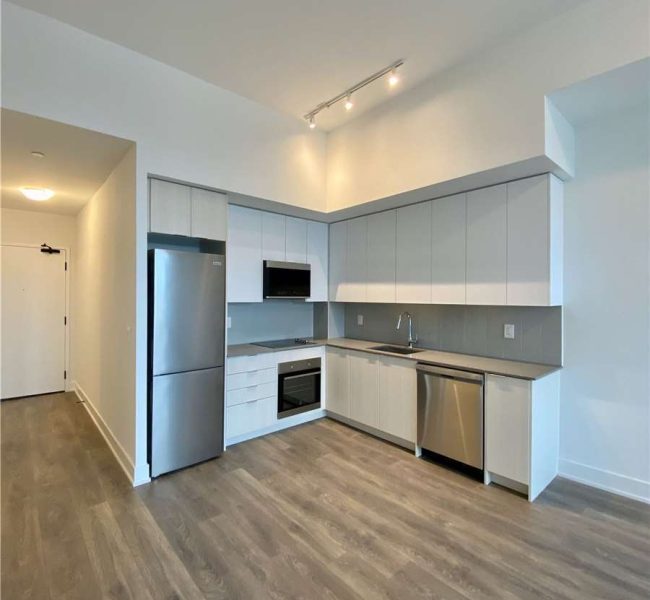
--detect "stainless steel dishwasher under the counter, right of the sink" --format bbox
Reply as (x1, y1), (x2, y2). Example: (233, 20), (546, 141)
(416, 363), (483, 469)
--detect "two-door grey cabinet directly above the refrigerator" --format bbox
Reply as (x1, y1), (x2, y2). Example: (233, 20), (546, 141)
(149, 179), (228, 240)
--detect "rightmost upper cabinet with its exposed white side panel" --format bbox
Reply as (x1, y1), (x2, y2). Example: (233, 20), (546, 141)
(507, 175), (562, 306)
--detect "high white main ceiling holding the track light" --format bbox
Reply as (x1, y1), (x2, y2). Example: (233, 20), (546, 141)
(6, 0), (584, 130)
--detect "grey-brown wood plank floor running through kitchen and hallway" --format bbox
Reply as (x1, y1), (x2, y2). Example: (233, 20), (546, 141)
(5, 394), (650, 600)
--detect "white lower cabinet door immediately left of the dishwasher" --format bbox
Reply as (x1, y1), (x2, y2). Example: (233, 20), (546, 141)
(379, 357), (417, 443)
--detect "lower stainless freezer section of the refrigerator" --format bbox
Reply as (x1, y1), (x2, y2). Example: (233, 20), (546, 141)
(150, 367), (224, 477)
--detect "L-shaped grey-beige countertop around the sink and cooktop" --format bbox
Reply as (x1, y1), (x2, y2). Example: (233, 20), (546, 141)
(228, 338), (561, 380)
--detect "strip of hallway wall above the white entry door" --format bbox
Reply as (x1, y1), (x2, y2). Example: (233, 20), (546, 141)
(2, 208), (76, 250)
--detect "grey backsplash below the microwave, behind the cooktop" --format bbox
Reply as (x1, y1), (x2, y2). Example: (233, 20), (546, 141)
(228, 300), (314, 344)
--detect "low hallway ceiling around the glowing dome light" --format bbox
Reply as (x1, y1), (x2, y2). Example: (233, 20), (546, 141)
(2, 109), (132, 215)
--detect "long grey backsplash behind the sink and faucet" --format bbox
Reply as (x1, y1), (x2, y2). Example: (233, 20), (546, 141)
(345, 303), (562, 365)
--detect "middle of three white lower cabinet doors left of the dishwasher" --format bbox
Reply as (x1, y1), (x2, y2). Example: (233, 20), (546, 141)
(348, 353), (379, 429)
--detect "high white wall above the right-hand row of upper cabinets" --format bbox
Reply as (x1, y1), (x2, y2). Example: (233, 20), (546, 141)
(327, 0), (649, 211)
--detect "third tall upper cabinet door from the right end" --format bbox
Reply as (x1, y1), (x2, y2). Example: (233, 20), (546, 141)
(431, 194), (467, 304)
